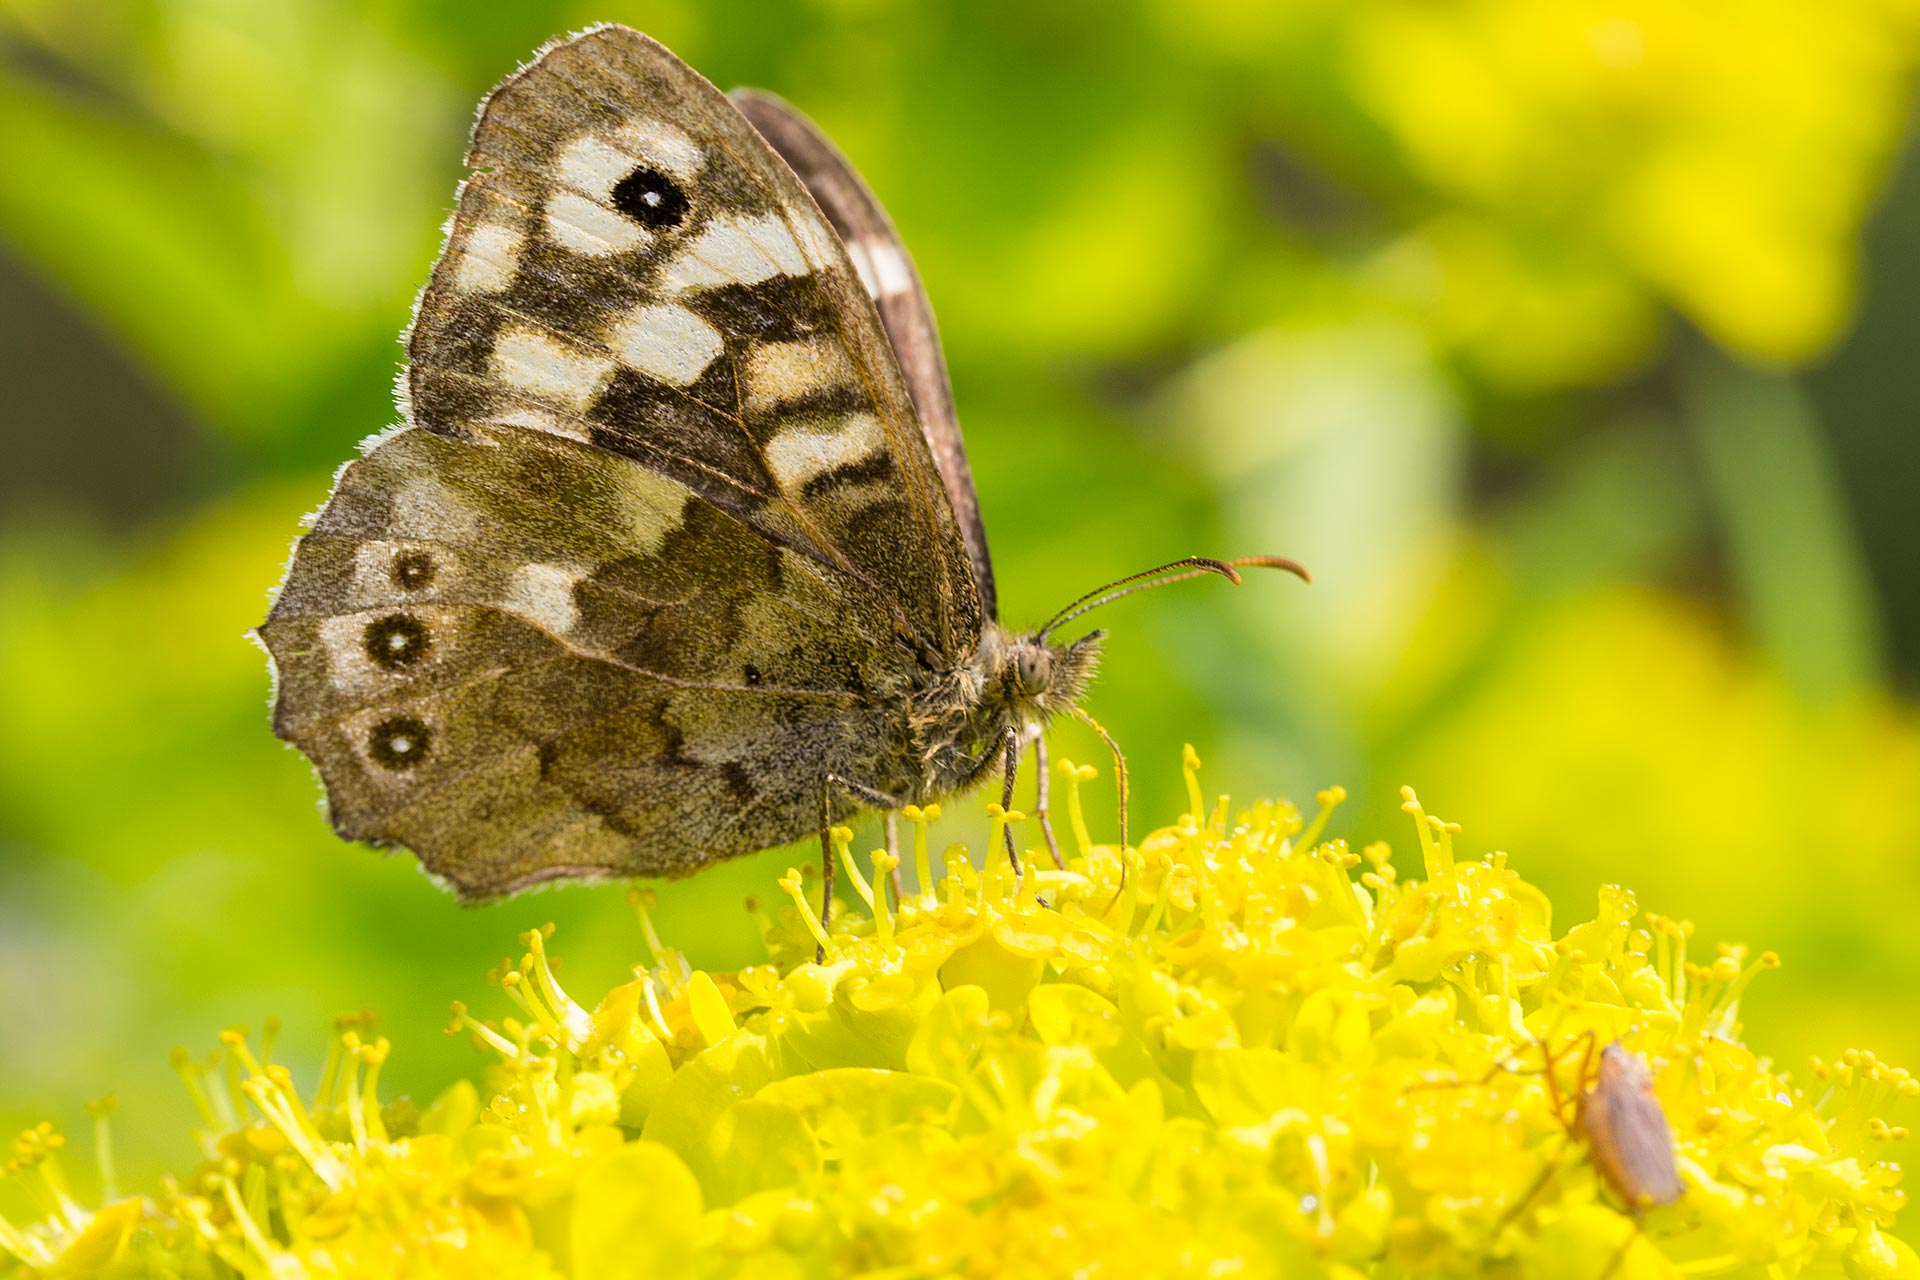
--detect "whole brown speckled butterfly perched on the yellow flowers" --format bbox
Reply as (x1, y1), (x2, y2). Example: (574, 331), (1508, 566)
(259, 25), (1292, 898)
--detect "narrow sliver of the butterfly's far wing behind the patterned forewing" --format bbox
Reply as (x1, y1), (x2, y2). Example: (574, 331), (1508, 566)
(732, 90), (998, 618)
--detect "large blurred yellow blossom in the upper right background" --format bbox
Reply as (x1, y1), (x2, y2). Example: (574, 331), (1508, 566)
(1336, 0), (1920, 386)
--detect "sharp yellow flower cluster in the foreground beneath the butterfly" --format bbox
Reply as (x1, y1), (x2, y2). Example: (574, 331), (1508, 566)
(0, 750), (1920, 1280)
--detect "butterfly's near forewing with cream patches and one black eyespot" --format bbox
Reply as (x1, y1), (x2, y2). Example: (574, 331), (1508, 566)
(409, 27), (979, 652)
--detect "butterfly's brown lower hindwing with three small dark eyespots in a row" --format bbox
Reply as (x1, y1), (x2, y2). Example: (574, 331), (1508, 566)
(263, 428), (913, 896)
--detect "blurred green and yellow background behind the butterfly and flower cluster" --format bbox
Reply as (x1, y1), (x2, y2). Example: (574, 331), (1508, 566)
(0, 0), (1920, 1205)
